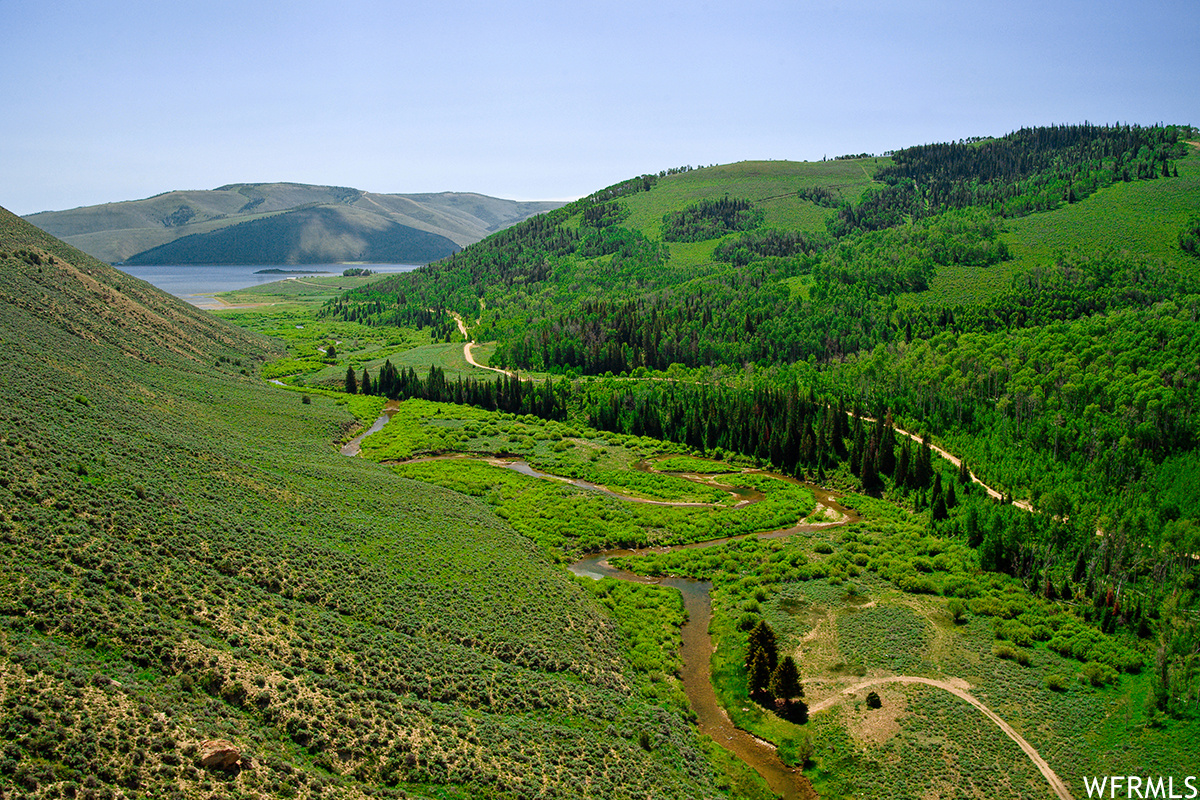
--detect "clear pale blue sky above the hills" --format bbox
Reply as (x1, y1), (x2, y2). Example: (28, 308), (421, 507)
(0, 0), (1200, 213)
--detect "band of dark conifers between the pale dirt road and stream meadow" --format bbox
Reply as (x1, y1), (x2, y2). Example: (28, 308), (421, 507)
(331, 362), (1200, 712)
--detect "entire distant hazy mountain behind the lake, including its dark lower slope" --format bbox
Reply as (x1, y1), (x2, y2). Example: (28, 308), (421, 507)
(25, 184), (563, 264)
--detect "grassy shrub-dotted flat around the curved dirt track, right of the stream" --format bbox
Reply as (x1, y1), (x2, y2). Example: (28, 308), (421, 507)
(620, 484), (1200, 798)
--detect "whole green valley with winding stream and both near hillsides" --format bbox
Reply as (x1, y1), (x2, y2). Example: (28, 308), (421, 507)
(0, 125), (1200, 800)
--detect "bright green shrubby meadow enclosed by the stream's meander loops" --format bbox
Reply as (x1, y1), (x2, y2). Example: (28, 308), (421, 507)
(348, 401), (814, 560)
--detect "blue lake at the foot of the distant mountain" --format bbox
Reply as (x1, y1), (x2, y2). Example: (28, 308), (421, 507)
(116, 264), (420, 305)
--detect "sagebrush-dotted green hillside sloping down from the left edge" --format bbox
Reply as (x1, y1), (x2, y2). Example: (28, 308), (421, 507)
(0, 212), (715, 798)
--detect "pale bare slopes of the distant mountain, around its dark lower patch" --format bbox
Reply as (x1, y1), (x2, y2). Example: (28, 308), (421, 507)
(26, 184), (562, 264)
